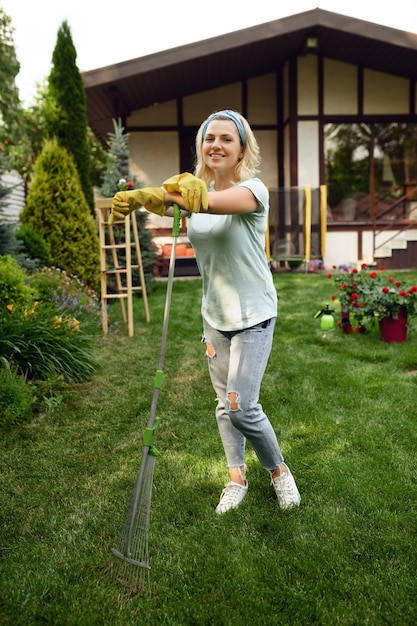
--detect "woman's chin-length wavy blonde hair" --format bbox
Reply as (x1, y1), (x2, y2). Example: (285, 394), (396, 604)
(194, 111), (261, 185)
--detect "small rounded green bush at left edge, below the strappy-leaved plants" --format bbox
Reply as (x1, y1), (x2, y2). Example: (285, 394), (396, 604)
(0, 367), (33, 426)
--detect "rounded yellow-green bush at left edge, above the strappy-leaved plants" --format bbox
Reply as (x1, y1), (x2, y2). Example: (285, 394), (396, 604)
(0, 255), (33, 318)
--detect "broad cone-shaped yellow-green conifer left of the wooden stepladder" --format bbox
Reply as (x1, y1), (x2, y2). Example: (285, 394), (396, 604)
(20, 139), (100, 291)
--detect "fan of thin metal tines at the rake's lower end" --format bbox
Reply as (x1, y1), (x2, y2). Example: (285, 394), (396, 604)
(110, 454), (155, 594)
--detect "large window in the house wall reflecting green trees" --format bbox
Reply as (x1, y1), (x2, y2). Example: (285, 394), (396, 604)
(324, 123), (417, 222)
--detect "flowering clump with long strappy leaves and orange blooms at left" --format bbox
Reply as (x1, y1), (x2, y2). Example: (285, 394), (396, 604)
(0, 267), (101, 382)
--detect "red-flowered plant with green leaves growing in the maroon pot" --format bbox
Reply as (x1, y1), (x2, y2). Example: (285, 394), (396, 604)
(327, 264), (417, 324)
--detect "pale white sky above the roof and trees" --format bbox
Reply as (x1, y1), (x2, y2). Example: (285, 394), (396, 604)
(0, 0), (417, 106)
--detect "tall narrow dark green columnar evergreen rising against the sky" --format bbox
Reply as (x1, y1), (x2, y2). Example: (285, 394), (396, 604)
(46, 21), (94, 212)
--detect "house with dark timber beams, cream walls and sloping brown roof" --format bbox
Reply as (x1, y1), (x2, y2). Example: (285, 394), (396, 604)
(83, 9), (417, 268)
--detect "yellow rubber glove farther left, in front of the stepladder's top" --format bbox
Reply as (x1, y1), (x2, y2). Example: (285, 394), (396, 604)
(109, 187), (166, 224)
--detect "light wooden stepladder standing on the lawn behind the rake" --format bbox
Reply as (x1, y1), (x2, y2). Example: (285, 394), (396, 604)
(95, 198), (150, 337)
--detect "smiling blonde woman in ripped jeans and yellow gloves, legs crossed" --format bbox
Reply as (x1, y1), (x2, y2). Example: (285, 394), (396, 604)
(113, 110), (300, 514)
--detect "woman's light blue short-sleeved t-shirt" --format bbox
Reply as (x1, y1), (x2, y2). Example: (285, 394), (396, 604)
(188, 178), (278, 331)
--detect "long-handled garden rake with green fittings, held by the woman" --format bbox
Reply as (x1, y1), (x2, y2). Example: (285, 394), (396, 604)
(110, 204), (181, 595)
